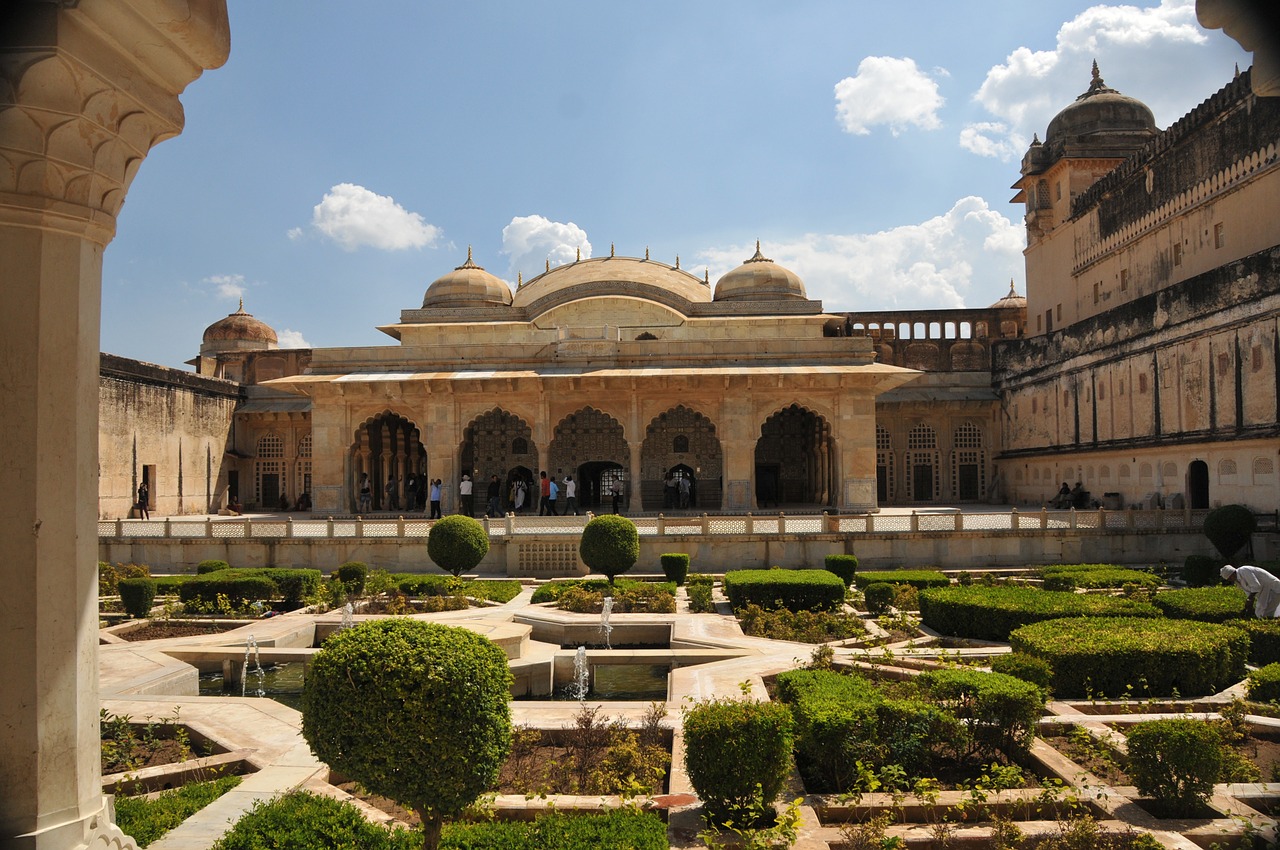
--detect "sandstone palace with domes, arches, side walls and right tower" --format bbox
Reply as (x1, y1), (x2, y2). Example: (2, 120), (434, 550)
(100, 67), (1280, 517)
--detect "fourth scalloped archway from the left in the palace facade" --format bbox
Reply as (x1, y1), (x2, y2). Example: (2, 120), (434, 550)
(640, 405), (724, 511)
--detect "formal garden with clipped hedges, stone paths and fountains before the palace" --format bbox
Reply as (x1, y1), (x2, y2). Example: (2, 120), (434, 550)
(94, 506), (1280, 850)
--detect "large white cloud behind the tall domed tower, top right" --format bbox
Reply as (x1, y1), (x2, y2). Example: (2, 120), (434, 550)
(960, 0), (1248, 159)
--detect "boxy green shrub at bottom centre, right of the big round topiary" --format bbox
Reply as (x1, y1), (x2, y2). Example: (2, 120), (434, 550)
(685, 696), (793, 826)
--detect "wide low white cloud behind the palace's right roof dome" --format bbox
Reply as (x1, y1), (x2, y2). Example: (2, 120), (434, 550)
(700, 196), (1025, 310)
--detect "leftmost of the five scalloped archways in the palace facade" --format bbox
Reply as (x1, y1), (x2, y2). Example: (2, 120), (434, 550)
(347, 411), (426, 511)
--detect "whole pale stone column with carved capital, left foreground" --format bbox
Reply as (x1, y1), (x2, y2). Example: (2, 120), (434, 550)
(0, 8), (229, 850)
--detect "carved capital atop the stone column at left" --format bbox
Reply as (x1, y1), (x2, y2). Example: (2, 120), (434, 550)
(0, 0), (230, 245)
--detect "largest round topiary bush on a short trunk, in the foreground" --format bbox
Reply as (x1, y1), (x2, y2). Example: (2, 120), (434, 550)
(302, 620), (512, 849)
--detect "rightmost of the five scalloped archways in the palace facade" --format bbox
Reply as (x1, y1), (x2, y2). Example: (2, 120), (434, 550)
(755, 405), (836, 508)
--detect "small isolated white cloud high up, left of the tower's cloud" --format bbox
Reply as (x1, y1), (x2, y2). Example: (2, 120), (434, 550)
(836, 56), (943, 136)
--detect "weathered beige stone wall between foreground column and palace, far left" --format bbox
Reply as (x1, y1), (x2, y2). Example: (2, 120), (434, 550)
(97, 355), (242, 518)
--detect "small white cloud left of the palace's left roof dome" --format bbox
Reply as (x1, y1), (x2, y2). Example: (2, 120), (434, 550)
(305, 183), (440, 251)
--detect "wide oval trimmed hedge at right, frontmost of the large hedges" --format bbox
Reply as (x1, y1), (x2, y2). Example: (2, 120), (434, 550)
(1009, 617), (1249, 698)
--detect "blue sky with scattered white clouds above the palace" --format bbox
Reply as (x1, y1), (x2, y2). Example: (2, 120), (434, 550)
(102, 0), (1251, 366)
